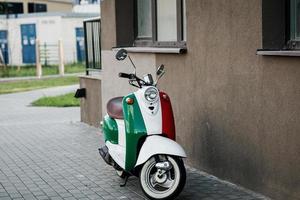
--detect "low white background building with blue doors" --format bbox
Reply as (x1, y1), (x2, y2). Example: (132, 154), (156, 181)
(0, 13), (97, 66)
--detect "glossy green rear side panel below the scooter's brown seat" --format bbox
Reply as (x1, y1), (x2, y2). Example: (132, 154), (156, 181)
(102, 115), (118, 144)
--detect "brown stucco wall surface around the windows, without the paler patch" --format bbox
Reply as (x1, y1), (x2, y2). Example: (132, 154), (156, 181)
(101, 0), (300, 200)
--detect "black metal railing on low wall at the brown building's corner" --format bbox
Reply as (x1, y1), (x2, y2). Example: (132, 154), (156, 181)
(83, 17), (101, 75)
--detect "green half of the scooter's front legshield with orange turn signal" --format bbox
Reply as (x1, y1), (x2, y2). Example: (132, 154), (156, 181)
(123, 94), (147, 171)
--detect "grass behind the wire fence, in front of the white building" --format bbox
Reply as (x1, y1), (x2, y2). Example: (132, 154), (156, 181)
(0, 63), (85, 78)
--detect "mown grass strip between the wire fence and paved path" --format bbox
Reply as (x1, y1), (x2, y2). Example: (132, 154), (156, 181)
(0, 76), (79, 94)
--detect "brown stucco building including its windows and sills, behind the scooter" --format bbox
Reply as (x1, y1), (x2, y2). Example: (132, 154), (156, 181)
(81, 0), (300, 200)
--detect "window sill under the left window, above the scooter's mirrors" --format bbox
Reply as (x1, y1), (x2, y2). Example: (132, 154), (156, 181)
(113, 47), (187, 54)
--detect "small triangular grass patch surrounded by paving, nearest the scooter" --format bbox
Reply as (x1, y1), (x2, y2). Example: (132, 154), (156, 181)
(31, 92), (80, 107)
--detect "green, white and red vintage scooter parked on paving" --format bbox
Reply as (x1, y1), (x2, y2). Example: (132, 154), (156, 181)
(99, 49), (186, 199)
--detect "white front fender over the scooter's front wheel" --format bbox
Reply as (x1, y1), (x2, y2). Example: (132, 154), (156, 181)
(135, 135), (186, 167)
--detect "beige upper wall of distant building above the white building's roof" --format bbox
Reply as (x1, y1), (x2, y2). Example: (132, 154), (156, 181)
(0, 0), (73, 13)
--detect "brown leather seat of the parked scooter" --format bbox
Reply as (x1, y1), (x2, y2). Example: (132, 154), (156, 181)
(106, 97), (124, 119)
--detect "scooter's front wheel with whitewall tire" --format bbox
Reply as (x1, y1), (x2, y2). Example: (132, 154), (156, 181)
(139, 155), (186, 200)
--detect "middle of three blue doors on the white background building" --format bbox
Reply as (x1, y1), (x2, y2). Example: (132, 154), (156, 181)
(21, 24), (36, 64)
